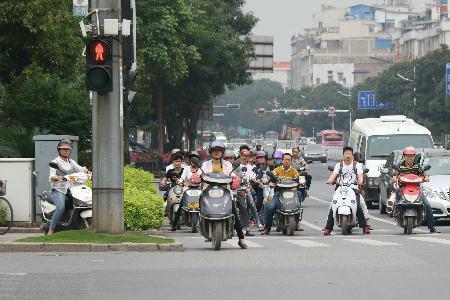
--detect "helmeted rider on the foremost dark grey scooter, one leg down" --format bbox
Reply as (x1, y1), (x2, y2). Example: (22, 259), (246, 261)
(202, 141), (247, 249)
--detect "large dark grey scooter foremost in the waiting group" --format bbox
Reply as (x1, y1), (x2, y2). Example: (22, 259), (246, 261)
(199, 173), (235, 250)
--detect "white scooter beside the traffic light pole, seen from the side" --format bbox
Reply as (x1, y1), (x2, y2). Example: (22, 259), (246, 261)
(38, 162), (92, 232)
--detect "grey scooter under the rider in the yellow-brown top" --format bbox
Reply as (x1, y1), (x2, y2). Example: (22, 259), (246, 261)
(267, 171), (303, 236)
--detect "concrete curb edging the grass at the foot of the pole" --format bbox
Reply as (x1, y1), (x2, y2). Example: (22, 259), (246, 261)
(0, 243), (184, 252)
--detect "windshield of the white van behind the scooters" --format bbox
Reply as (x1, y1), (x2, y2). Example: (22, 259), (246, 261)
(367, 134), (433, 158)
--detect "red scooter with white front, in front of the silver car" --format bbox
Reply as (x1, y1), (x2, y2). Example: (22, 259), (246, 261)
(393, 165), (431, 235)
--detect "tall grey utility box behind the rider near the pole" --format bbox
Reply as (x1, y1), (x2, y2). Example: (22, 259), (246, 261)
(33, 134), (79, 221)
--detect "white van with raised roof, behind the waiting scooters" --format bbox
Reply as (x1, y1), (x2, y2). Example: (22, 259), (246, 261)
(348, 115), (433, 206)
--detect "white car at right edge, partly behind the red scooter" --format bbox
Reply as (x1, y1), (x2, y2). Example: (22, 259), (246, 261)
(420, 149), (450, 219)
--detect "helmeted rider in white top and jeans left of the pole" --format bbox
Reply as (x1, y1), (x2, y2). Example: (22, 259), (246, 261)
(47, 139), (89, 235)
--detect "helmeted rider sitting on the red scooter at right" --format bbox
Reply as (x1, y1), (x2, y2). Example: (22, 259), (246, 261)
(392, 147), (437, 233)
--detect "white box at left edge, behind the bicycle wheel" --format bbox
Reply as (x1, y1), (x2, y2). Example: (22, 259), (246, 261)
(0, 158), (35, 223)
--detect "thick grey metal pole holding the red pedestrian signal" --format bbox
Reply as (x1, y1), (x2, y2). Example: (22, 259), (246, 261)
(90, 0), (124, 234)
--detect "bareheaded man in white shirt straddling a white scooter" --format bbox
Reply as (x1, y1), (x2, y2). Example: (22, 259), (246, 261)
(323, 147), (370, 235)
